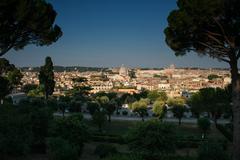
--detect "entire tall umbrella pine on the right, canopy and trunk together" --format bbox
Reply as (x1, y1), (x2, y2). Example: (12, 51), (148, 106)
(165, 0), (240, 160)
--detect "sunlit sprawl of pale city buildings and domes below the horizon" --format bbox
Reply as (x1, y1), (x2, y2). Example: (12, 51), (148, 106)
(22, 65), (231, 98)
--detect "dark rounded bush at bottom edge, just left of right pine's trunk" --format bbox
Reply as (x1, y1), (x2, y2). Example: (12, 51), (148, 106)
(197, 142), (230, 160)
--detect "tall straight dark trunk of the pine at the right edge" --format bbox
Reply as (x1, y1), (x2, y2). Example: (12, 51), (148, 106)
(230, 57), (240, 160)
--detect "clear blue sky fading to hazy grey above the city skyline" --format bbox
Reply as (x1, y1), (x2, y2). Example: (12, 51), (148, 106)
(5, 0), (228, 68)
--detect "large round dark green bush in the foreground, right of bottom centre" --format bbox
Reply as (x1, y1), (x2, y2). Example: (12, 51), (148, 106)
(128, 121), (176, 159)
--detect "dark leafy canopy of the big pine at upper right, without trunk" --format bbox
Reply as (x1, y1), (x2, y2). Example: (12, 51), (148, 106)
(165, 0), (228, 57)
